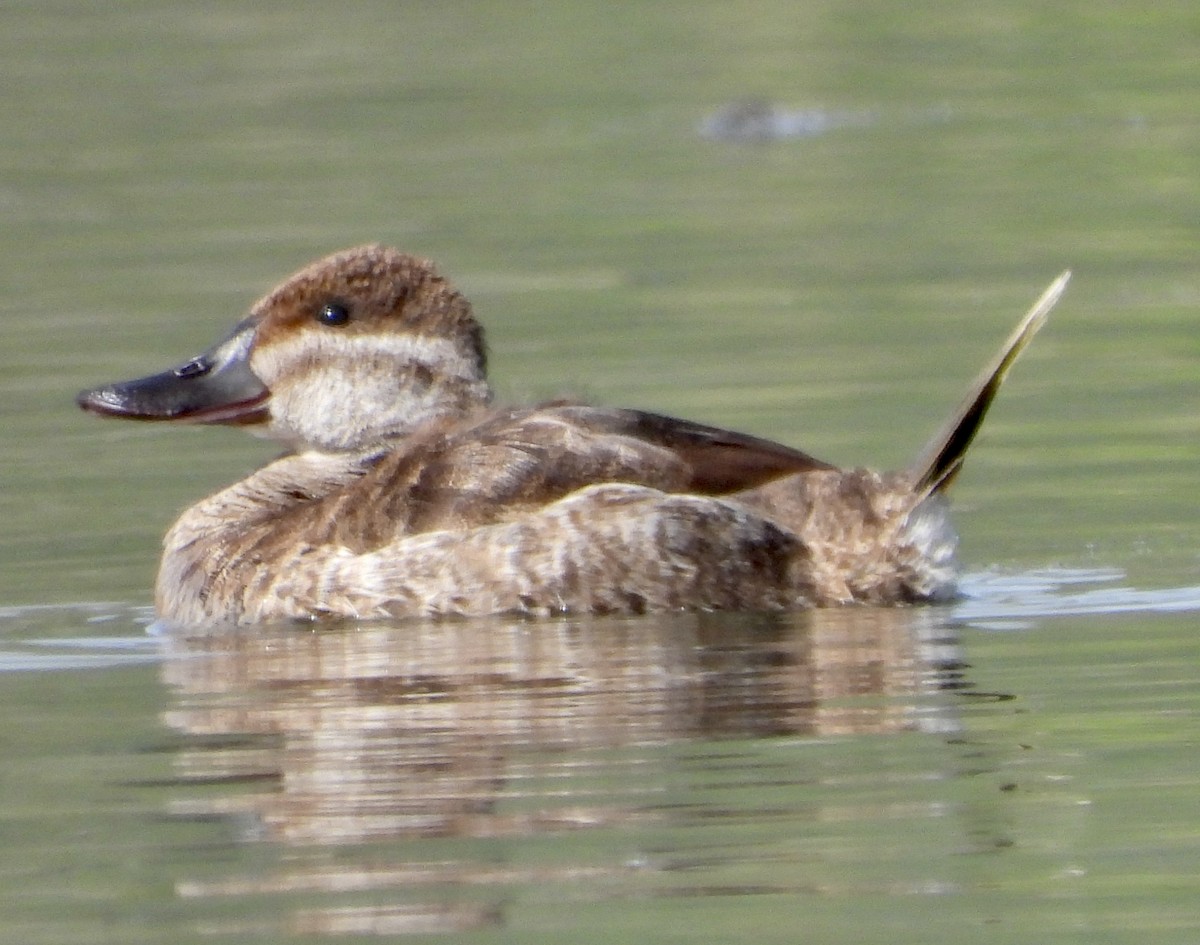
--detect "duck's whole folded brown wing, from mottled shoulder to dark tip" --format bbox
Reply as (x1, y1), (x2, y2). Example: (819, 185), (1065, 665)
(343, 402), (833, 547)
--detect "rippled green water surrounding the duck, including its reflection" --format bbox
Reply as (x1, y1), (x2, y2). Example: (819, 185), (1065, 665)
(0, 0), (1200, 944)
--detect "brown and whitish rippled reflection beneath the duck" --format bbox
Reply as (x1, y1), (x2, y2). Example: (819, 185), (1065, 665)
(163, 608), (960, 934)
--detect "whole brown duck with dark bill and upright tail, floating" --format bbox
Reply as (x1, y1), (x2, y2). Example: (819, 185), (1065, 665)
(77, 245), (1070, 626)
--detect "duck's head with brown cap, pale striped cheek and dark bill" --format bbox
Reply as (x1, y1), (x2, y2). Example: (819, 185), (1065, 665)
(77, 246), (491, 451)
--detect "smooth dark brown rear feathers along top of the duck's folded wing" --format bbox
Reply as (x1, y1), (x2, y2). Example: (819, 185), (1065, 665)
(552, 404), (834, 495)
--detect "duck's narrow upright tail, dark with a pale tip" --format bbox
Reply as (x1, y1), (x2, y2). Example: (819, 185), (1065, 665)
(912, 270), (1070, 496)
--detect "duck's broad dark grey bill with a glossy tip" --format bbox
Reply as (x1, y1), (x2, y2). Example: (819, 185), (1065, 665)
(76, 319), (270, 423)
